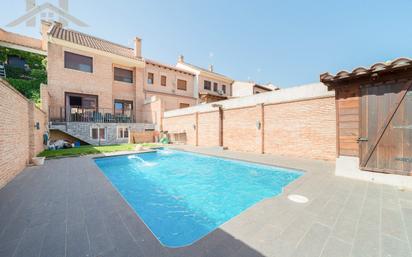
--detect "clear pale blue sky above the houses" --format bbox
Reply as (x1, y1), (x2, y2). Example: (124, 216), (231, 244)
(0, 0), (412, 87)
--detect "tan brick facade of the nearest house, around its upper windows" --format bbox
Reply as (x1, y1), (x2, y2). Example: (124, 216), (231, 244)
(46, 43), (144, 120)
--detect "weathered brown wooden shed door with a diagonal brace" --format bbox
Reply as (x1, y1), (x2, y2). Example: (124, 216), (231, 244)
(358, 81), (412, 175)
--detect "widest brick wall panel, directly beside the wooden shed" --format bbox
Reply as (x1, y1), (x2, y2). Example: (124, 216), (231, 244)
(264, 97), (336, 160)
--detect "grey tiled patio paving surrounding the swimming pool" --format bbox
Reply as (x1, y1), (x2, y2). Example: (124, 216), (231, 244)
(0, 147), (412, 257)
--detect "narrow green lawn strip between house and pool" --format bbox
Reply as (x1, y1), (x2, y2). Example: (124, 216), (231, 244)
(37, 144), (157, 158)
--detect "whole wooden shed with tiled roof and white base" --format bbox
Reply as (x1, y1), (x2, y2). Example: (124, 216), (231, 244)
(320, 58), (412, 186)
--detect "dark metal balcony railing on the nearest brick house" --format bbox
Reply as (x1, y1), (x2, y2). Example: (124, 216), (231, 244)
(49, 106), (135, 123)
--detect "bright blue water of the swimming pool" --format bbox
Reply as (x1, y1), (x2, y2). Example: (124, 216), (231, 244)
(96, 149), (302, 247)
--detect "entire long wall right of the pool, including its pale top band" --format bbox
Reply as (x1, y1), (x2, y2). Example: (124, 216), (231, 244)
(163, 85), (336, 160)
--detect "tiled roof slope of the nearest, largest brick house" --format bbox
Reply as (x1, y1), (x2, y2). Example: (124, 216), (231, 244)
(49, 25), (141, 60)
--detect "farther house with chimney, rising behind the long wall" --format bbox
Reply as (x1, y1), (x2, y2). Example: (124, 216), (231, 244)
(176, 55), (233, 103)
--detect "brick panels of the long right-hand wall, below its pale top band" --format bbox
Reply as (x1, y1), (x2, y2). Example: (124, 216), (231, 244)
(163, 96), (336, 160)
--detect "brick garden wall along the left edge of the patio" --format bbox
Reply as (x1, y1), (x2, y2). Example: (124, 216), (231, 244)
(0, 80), (46, 188)
